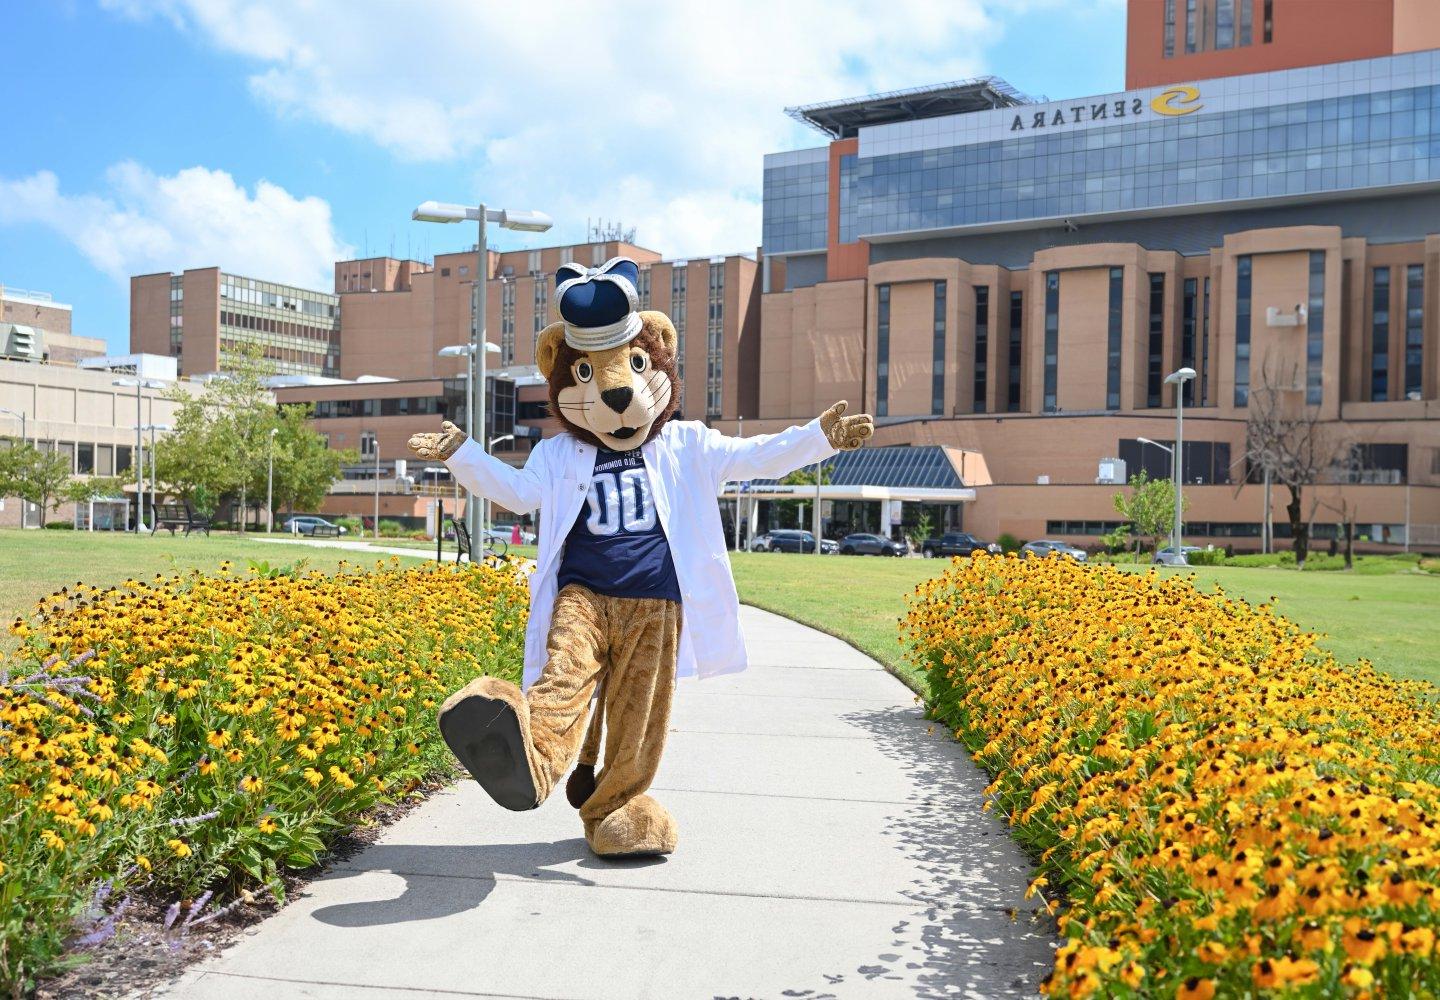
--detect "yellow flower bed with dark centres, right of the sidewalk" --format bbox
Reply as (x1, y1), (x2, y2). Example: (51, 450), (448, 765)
(903, 556), (1440, 999)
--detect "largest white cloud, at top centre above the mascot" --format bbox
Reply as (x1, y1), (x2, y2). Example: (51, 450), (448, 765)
(104, 0), (1019, 255)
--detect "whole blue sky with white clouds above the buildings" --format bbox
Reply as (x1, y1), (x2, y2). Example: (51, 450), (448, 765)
(0, 0), (1125, 352)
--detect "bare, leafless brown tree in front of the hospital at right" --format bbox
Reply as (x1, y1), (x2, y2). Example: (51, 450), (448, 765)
(1246, 360), (1336, 569)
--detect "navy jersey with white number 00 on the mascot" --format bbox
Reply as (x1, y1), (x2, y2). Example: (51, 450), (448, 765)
(557, 448), (680, 601)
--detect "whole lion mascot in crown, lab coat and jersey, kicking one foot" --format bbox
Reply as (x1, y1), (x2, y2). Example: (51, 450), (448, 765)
(410, 258), (874, 857)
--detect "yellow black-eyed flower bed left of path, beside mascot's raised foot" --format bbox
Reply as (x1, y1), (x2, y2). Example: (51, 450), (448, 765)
(0, 563), (527, 993)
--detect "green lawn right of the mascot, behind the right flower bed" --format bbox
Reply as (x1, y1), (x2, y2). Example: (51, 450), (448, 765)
(730, 552), (1440, 686)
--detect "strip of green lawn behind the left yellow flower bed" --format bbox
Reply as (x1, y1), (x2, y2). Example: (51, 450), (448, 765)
(0, 530), (420, 648)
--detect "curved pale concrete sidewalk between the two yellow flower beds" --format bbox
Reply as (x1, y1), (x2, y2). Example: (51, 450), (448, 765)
(167, 608), (1054, 1000)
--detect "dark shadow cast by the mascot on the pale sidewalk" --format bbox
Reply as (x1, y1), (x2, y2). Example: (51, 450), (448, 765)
(311, 837), (599, 927)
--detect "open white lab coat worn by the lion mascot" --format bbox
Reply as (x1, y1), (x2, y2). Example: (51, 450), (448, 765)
(445, 418), (835, 687)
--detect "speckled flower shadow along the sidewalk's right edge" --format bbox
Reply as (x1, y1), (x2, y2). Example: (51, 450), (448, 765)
(823, 707), (1058, 997)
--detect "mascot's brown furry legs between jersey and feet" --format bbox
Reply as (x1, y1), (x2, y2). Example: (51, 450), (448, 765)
(526, 584), (681, 820)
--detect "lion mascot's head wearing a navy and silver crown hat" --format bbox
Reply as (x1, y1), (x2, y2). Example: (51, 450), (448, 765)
(536, 256), (680, 451)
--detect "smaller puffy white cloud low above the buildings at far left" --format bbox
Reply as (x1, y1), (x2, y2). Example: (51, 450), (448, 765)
(0, 161), (354, 290)
